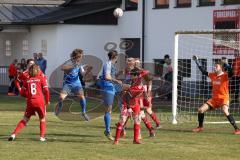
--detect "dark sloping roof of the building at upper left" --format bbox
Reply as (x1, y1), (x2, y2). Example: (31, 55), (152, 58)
(0, 0), (121, 25)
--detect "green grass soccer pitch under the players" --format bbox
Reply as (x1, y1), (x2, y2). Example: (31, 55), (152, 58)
(0, 95), (240, 160)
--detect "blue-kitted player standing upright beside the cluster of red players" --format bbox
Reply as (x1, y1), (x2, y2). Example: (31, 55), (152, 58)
(99, 50), (122, 140)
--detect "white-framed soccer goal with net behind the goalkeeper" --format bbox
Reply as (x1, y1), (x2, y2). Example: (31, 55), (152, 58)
(172, 30), (240, 124)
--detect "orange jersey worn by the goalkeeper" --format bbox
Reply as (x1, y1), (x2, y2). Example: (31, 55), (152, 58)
(208, 72), (229, 100)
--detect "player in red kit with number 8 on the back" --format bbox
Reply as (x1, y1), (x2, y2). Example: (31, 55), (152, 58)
(8, 64), (50, 141)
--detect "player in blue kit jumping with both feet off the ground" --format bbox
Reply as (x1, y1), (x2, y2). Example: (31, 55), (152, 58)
(55, 49), (89, 121)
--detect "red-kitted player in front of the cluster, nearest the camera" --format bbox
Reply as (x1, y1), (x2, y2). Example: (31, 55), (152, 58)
(114, 68), (144, 144)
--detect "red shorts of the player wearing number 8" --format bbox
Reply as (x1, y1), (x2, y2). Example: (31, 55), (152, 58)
(24, 107), (46, 119)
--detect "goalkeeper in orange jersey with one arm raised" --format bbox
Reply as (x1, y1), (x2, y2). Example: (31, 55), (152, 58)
(192, 56), (240, 135)
